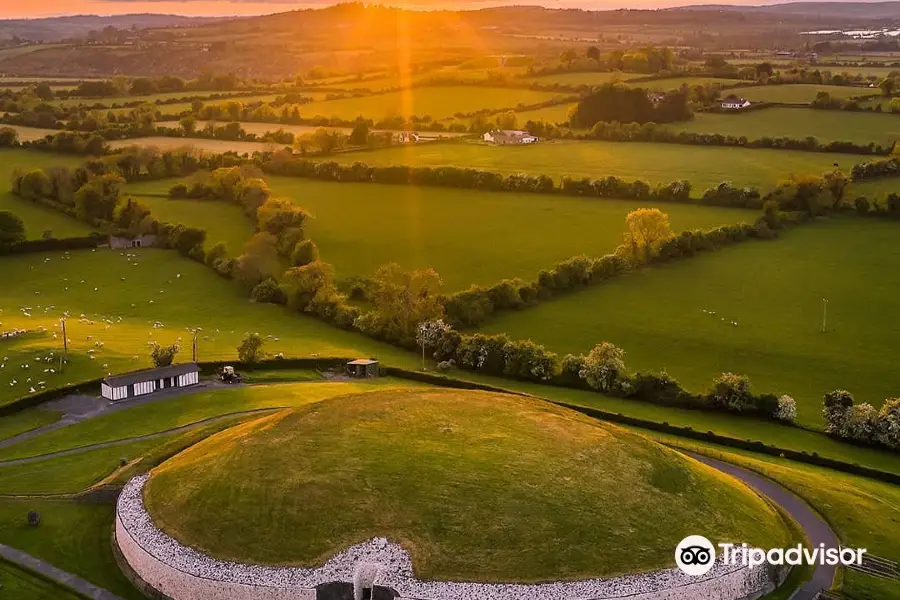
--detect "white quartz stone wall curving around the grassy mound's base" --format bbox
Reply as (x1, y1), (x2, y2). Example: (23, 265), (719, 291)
(115, 475), (774, 600)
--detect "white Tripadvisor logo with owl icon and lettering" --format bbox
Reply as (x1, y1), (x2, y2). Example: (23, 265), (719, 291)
(675, 535), (866, 576)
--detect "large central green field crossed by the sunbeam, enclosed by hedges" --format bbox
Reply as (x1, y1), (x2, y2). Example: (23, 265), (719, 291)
(128, 177), (756, 290)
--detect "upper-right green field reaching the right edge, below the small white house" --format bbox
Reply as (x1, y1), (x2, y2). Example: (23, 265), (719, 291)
(669, 107), (900, 146)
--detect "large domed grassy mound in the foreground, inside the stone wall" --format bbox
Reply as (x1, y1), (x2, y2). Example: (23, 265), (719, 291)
(144, 390), (787, 582)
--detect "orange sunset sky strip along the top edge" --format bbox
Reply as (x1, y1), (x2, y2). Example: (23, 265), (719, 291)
(0, 0), (828, 19)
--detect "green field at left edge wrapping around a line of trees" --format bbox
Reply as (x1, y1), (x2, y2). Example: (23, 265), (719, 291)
(0, 150), (91, 240)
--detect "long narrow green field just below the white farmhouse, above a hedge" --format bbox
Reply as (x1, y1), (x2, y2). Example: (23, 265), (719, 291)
(324, 141), (864, 190)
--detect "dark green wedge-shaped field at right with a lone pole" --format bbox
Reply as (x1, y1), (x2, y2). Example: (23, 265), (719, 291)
(484, 219), (900, 426)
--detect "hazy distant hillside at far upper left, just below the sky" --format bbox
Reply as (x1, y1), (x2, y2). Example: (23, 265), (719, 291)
(0, 14), (230, 42)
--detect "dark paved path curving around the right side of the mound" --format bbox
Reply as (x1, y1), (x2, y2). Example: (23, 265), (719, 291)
(680, 450), (841, 600)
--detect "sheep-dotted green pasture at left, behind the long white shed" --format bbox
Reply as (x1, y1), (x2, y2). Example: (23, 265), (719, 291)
(0, 249), (415, 404)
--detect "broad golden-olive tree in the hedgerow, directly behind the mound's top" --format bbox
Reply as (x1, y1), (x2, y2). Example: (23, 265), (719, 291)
(360, 263), (444, 345)
